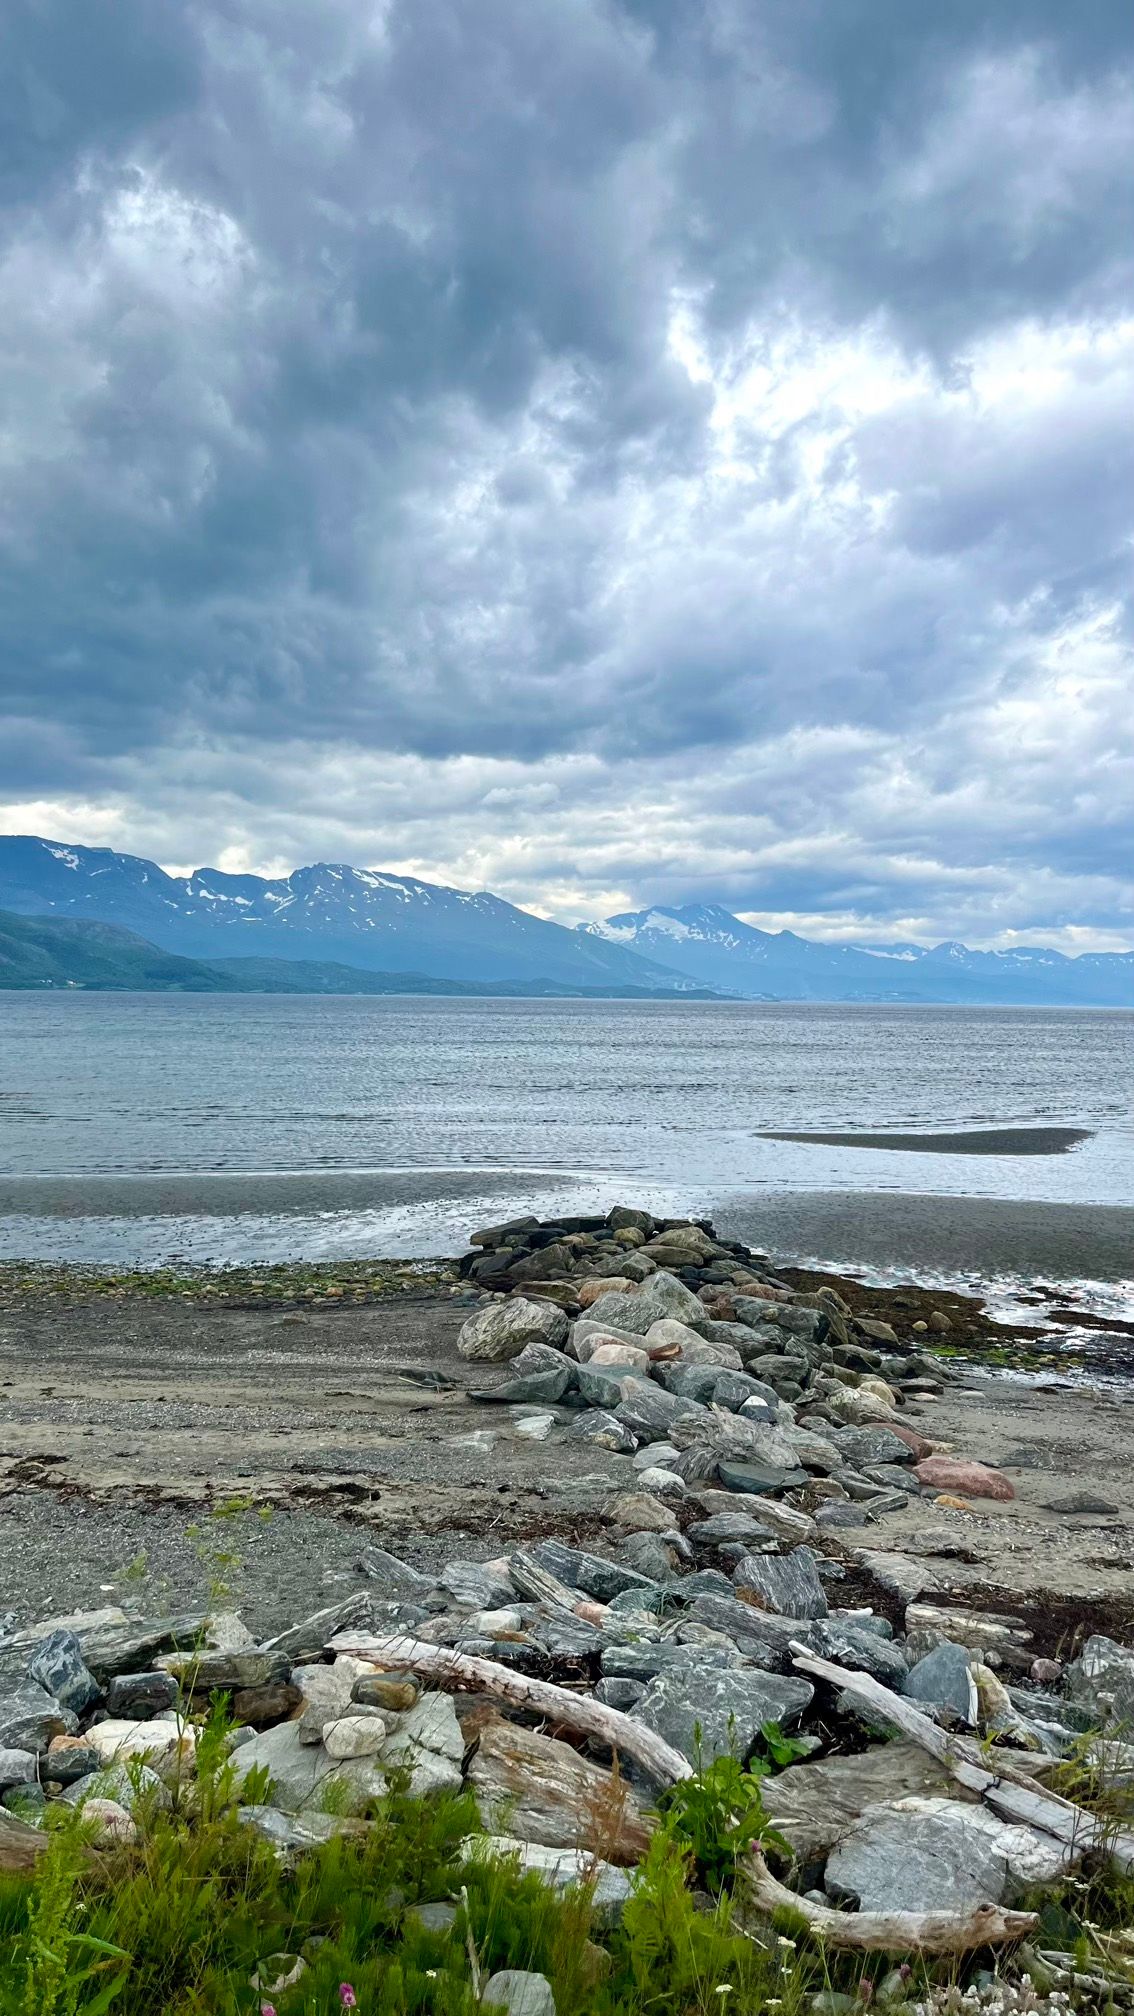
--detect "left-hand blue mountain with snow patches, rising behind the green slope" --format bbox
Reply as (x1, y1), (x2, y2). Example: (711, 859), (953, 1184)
(0, 839), (692, 994)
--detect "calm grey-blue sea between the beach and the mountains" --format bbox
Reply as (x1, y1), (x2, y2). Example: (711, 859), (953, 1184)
(0, 994), (1134, 1314)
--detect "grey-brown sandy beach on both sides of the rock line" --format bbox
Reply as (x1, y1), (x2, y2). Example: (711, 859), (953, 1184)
(0, 1296), (1134, 1629)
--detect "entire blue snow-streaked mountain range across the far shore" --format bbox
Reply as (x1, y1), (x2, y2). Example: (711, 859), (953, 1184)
(0, 837), (1134, 1008)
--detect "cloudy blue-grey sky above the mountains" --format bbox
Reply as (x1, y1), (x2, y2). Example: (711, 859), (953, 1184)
(0, 0), (1134, 952)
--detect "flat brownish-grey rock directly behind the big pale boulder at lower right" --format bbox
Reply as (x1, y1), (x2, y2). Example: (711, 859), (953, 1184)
(761, 1738), (950, 1863)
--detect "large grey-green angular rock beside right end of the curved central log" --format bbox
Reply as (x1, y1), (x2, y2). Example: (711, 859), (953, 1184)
(634, 1661), (815, 1764)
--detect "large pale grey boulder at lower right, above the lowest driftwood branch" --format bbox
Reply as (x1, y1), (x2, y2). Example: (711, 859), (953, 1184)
(825, 1794), (1061, 1911)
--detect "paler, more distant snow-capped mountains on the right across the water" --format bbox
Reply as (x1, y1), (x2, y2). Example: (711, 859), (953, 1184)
(579, 903), (1134, 1008)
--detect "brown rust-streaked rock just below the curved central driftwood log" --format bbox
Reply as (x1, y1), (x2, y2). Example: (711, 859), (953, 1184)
(468, 1720), (650, 1863)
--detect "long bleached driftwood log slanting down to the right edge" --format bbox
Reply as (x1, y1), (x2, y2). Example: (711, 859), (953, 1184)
(791, 1641), (1134, 1875)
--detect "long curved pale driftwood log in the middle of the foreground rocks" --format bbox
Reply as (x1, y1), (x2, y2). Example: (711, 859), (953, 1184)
(331, 1631), (692, 1786)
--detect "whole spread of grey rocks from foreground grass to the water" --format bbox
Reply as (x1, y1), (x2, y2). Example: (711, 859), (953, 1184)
(0, 1210), (1134, 2002)
